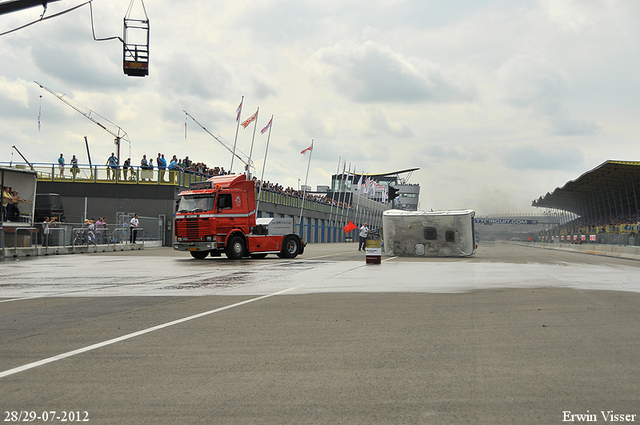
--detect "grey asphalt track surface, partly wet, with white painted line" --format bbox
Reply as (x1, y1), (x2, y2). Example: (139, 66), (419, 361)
(0, 243), (640, 424)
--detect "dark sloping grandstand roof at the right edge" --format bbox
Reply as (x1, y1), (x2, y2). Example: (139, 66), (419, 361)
(531, 160), (640, 216)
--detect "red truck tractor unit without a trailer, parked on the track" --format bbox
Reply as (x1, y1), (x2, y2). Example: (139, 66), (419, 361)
(173, 174), (304, 259)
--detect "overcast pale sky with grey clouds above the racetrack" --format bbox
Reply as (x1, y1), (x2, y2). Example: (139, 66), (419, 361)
(0, 0), (640, 215)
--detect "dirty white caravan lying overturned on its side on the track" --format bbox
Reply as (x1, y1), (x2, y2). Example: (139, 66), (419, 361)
(382, 210), (476, 257)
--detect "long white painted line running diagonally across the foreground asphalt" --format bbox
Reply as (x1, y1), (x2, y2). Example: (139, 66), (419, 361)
(0, 282), (312, 378)
